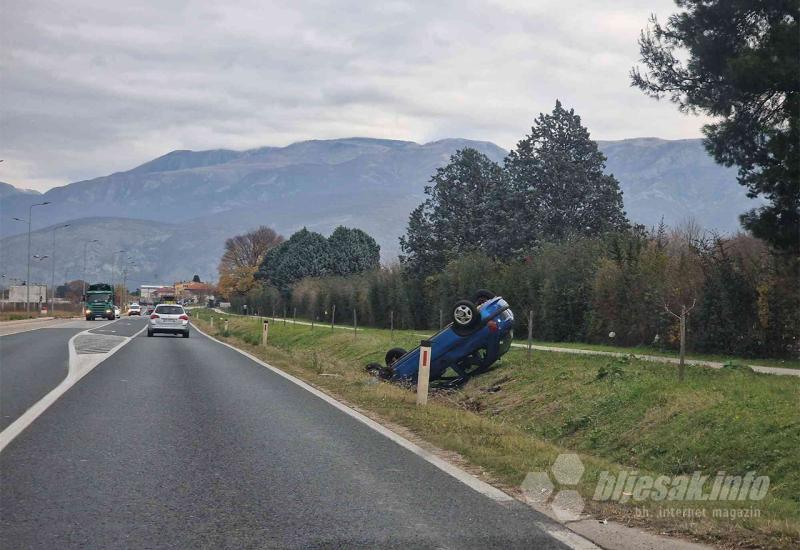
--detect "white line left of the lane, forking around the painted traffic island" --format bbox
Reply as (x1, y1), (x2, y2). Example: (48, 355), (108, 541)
(0, 327), (147, 452)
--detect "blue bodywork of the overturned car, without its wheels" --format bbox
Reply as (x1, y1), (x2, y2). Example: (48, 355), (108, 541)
(391, 296), (514, 382)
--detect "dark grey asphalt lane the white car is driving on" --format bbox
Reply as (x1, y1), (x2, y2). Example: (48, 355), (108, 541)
(0, 325), (562, 549)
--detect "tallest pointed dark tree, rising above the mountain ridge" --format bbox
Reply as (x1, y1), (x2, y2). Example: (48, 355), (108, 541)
(505, 101), (628, 253)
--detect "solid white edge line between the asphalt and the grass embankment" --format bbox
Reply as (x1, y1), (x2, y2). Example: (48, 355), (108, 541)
(192, 325), (599, 550)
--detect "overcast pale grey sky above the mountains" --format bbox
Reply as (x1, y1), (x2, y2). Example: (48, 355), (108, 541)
(0, 0), (703, 194)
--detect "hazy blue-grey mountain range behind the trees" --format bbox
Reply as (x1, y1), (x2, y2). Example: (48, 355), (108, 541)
(0, 138), (758, 286)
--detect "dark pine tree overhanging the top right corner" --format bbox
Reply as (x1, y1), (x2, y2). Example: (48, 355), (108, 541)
(631, 0), (800, 255)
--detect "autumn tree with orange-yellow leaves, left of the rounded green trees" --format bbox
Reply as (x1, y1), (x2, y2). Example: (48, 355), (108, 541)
(217, 225), (283, 297)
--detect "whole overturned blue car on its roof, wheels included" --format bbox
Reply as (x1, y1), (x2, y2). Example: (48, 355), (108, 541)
(367, 290), (514, 385)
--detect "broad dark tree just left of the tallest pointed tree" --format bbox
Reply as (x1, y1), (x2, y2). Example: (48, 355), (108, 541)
(400, 148), (506, 274)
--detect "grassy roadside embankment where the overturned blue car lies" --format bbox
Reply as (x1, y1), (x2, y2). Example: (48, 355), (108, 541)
(194, 310), (800, 547)
